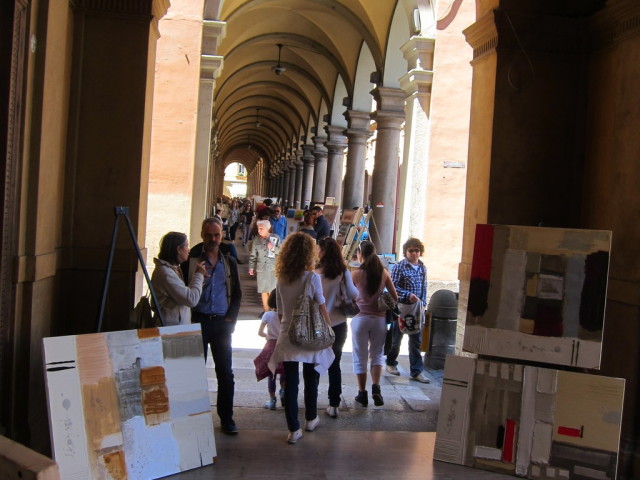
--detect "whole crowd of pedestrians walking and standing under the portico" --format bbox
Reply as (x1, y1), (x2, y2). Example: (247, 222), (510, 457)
(152, 199), (429, 444)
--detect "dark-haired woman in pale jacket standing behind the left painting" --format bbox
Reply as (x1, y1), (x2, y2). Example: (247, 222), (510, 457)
(151, 232), (206, 326)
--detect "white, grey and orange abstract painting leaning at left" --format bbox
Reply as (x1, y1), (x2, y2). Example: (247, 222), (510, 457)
(44, 324), (216, 480)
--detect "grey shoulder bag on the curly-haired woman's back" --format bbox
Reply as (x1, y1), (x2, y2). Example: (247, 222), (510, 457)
(288, 273), (336, 351)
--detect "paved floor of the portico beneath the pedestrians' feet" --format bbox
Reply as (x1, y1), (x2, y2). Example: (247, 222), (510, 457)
(160, 238), (509, 480)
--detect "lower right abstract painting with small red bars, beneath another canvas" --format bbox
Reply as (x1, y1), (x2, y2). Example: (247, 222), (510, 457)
(434, 356), (624, 480)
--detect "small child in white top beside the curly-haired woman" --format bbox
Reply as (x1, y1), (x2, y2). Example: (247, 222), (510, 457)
(253, 289), (284, 410)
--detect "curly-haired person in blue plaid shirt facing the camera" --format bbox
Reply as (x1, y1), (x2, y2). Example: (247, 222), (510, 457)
(387, 238), (429, 383)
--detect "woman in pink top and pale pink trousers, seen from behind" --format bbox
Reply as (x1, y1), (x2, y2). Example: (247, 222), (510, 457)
(351, 241), (398, 407)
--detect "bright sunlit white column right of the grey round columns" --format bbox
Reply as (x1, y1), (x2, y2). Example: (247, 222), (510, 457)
(396, 37), (442, 249)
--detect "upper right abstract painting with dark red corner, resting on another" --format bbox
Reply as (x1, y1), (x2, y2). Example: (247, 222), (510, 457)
(463, 225), (611, 369)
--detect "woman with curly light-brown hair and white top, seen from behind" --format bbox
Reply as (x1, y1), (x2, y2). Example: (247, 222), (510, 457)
(269, 232), (334, 443)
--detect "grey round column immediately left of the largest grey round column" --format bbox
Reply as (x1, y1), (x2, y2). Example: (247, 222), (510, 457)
(341, 110), (372, 208)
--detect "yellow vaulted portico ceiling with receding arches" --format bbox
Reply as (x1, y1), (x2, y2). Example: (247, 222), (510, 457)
(212, 0), (396, 169)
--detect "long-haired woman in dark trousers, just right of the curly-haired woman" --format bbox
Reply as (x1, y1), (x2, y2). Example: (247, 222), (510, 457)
(316, 237), (358, 418)
